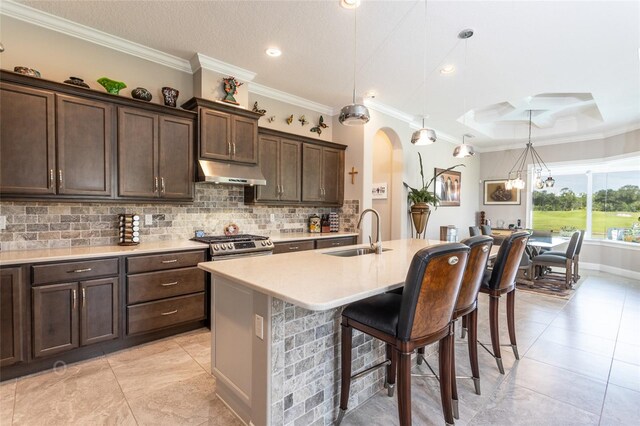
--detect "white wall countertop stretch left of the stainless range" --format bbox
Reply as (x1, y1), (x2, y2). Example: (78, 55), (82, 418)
(0, 240), (209, 266)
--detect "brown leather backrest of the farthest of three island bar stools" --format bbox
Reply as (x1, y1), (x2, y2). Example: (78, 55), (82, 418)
(489, 231), (529, 290)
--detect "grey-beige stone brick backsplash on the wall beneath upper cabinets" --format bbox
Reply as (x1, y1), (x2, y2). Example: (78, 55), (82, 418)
(0, 183), (360, 250)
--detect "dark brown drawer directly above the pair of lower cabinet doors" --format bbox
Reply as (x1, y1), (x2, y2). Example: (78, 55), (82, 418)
(31, 259), (118, 285)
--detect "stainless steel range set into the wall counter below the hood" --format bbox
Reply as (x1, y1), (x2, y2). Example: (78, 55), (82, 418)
(192, 234), (273, 260)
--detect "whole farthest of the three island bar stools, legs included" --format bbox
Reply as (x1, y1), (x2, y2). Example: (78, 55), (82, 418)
(478, 231), (529, 374)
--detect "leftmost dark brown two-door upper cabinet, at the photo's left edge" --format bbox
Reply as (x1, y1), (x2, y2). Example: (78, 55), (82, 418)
(0, 82), (113, 197)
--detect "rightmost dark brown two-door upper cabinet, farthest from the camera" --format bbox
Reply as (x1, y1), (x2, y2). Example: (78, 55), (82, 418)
(302, 143), (344, 205)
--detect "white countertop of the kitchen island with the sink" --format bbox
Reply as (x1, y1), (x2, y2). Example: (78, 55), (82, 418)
(198, 239), (445, 311)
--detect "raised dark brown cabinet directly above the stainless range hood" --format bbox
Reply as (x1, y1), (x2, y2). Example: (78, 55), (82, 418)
(182, 98), (261, 164)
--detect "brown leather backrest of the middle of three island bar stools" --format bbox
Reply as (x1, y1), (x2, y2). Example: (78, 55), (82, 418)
(455, 235), (493, 311)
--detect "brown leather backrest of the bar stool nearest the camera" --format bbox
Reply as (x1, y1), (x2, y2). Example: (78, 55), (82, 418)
(397, 243), (469, 341)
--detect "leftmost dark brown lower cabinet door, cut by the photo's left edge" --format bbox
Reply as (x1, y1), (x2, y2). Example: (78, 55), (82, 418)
(0, 268), (26, 367)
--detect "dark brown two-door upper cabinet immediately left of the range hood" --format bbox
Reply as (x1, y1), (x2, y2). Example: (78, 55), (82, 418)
(118, 107), (194, 200)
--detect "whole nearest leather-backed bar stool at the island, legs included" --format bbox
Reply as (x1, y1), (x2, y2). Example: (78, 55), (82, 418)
(336, 243), (469, 426)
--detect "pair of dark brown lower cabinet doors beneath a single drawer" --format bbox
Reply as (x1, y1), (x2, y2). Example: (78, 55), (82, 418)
(32, 277), (119, 358)
